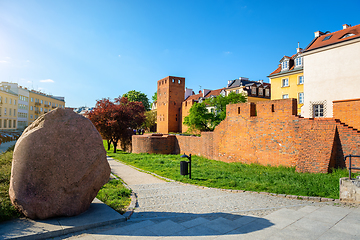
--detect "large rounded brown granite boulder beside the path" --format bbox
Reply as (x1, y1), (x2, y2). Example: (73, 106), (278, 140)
(9, 108), (110, 219)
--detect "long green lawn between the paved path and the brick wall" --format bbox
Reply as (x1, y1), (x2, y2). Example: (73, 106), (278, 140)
(104, 141), (359, 199)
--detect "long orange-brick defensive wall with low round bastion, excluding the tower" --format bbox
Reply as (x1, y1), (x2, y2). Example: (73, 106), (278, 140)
(132, 99), (360, 173)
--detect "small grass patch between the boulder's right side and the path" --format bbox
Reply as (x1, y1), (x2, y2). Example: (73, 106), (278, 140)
(96, 180), (131, 214)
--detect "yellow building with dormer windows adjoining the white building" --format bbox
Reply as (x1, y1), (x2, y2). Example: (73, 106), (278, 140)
(268, 48), (304, 115)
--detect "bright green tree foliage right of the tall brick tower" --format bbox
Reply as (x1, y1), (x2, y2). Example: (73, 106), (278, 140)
(184, 92), (246, 131)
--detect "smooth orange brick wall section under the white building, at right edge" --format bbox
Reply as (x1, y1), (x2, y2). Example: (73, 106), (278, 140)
(333, 99), (360, 130)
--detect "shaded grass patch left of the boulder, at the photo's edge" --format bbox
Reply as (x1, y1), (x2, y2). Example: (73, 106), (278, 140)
(0, 144), (21, 222)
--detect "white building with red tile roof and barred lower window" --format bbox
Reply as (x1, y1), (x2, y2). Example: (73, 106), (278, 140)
(301, 24), (360, 118)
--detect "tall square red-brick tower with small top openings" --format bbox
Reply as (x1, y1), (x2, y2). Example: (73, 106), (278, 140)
(157, 76), (185, 133)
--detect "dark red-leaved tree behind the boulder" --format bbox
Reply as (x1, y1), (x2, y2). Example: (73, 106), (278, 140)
(88, 97), (145, 153)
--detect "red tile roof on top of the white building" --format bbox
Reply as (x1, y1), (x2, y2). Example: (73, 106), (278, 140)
(305, 24), (360, 51)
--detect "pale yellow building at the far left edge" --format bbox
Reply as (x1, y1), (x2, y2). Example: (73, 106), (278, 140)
(0, 87), (18, 130)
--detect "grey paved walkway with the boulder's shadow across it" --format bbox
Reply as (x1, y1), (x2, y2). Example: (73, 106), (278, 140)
(55, 158), (360, 239)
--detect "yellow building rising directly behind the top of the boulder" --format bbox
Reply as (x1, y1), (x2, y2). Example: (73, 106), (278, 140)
(28, 90), (65, 125)
